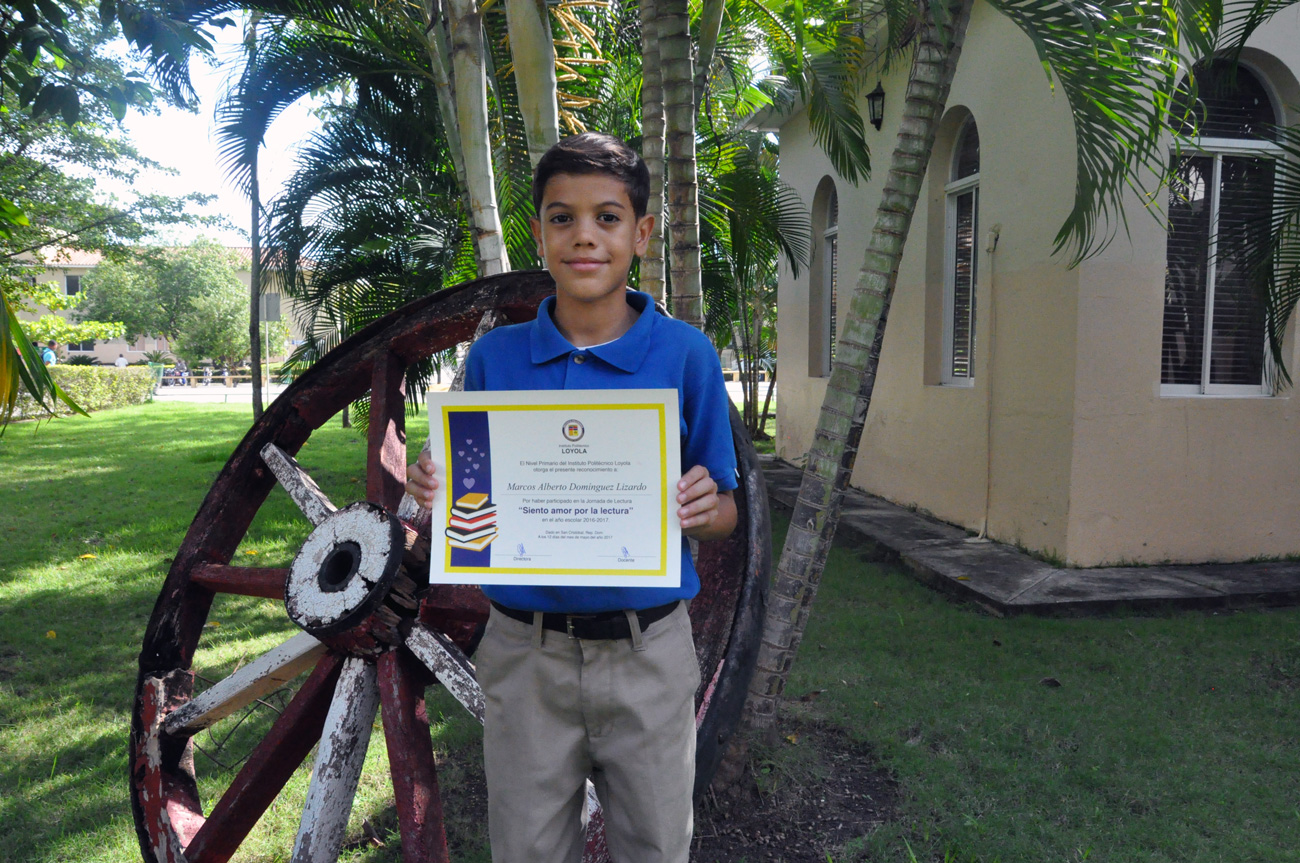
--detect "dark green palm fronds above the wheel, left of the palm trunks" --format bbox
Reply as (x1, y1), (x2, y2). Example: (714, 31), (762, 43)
(218, 15), (470, 413)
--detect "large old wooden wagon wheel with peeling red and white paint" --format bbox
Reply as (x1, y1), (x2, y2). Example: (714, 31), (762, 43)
(130, 272), (771, 863)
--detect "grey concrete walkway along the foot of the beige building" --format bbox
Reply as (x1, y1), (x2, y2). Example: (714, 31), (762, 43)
(763, 457), (1300, 615)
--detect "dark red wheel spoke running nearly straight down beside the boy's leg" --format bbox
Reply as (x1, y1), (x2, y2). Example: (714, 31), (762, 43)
(378, 650), (449, 863)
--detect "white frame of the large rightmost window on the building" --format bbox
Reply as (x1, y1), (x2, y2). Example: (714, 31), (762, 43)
(1160, 138), (1284, 398)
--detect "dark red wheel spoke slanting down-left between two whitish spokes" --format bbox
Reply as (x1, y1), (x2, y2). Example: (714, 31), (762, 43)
(185, 654), (343, 863)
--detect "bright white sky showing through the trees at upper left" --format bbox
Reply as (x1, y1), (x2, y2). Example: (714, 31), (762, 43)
(109, 26), (327, 246)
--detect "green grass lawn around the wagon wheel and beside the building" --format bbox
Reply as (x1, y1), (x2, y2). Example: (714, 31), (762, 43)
(0, 404), (1300, 863)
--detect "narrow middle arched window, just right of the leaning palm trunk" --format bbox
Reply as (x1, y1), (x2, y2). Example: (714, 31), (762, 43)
(941, 120), (979, 386)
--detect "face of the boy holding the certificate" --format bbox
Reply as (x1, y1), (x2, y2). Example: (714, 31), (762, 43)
(533, 174), (654, 302)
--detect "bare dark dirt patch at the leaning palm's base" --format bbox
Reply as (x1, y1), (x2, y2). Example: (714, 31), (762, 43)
(692, 724), (898, 863)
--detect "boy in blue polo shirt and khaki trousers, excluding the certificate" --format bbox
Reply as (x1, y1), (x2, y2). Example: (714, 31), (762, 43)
(407, 133), (736, 863)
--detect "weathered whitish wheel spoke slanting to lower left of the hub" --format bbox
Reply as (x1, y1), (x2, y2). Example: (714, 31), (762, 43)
(163, 632), (325, 736)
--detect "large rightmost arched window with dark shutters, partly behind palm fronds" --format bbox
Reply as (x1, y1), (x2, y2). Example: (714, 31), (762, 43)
(1160, 60), (1281, 395)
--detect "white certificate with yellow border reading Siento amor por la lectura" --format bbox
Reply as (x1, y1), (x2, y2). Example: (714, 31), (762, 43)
(429, 390), (681, 587)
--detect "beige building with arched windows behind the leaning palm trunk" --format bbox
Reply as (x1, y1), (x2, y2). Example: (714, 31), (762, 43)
(776, 4), (1300, 567)
